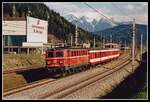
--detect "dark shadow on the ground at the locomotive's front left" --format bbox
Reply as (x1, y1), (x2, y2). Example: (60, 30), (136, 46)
(17, 68), (57, 83)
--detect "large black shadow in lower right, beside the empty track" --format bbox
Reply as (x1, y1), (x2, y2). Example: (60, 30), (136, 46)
(101, 53), (147, 99)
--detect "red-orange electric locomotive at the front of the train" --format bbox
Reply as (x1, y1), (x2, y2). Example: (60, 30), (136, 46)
(46, 49), (89, 74)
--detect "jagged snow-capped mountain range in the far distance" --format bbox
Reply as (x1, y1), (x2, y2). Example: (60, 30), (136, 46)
(65, 14), (114, 32)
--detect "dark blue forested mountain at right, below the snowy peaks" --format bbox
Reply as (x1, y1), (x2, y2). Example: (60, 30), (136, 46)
(93, 24), (147, 45)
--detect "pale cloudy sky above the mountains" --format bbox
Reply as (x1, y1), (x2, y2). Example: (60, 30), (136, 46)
(45, 2), (148, 24)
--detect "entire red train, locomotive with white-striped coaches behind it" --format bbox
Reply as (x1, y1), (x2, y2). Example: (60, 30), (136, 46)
(46, 48), (120, 75)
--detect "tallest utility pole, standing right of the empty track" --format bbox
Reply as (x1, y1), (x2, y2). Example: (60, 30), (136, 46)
(132, 19), (135, 71)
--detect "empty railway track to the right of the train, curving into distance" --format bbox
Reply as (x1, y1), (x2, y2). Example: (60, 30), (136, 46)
(37, 55), (134, 99)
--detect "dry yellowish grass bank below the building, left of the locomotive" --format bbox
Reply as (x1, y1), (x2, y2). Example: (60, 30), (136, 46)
(3, 53), (45, 70)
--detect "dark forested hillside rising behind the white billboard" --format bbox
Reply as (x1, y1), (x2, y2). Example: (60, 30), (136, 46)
(3, 3), (92, 42)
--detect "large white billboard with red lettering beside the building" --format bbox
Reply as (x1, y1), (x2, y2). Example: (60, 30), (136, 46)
(27, 16), (48, 43)
